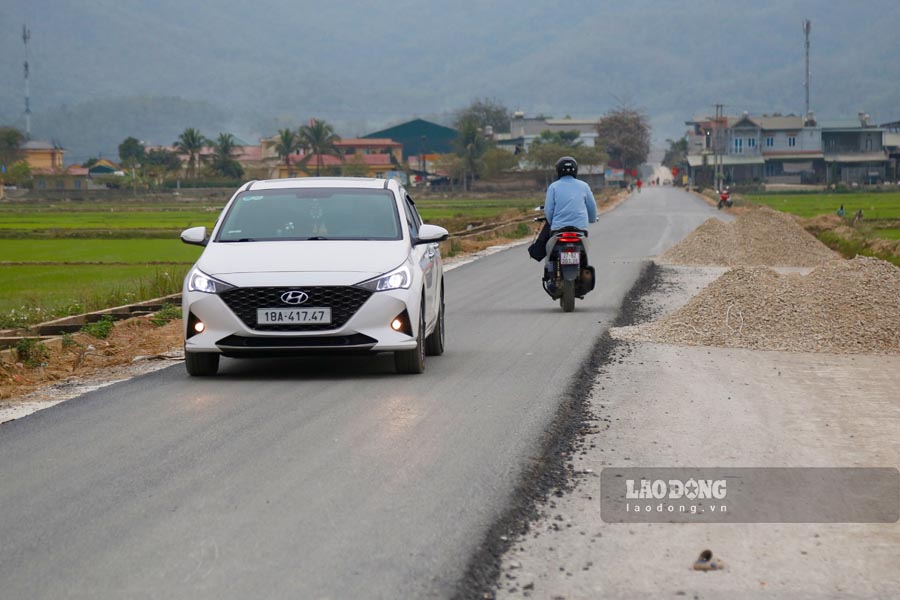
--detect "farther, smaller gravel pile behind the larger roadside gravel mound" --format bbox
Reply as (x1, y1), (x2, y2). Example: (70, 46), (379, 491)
(659, 207), (836, 267)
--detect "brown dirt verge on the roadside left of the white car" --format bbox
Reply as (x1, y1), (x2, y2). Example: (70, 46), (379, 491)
(0, 317), (183, 407)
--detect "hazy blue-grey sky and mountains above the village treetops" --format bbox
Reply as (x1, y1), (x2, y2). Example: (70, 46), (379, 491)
(0, 0), (900, 159)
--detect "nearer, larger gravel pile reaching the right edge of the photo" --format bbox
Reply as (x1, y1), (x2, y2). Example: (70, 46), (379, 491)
(614, 256), (900, 354)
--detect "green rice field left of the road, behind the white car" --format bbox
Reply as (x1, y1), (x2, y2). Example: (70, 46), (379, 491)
(0, 198), (542, 329)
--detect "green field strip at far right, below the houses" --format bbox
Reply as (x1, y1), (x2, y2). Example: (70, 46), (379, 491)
(747, 192), (900, 221)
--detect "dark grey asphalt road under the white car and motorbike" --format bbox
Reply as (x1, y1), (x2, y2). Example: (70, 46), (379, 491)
(0, 188), (716, 599)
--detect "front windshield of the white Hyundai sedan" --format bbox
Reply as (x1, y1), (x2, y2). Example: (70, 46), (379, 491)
(217, 188), (402, 242)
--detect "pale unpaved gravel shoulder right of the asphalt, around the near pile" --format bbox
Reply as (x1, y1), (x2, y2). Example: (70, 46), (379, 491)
(496, 267), (900, 598)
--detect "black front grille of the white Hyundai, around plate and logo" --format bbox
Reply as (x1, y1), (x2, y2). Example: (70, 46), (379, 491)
(219, 286), (372, 331)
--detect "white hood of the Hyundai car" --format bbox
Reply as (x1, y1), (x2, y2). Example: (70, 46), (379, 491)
(197, 240), (409, 281)
